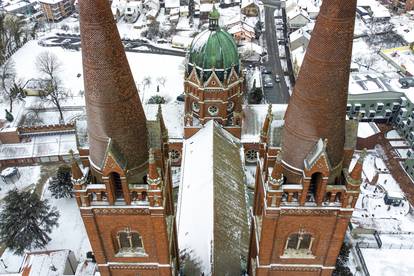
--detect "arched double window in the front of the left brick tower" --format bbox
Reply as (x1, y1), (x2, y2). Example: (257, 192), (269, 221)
(116, 228), (145, 257)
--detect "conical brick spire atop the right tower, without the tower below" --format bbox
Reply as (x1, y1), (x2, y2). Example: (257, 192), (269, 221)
(282, 0), (357, 172)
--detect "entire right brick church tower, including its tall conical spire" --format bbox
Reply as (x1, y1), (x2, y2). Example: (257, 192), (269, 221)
(248, 0), (363, 276)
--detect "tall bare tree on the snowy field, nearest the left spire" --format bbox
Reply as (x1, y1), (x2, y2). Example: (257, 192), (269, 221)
(36, 51), (69, 123)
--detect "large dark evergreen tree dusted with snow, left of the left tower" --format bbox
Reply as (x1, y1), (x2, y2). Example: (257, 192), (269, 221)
(0, 189), (59, 254)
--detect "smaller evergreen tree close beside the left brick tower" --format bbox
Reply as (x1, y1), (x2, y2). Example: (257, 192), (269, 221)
(49, 165), (73, 198)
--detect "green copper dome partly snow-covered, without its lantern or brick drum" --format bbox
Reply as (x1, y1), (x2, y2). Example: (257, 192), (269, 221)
(188, 27), (239, 71)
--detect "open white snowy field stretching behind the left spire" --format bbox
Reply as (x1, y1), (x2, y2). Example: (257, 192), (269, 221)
(12, 40), (184, 105)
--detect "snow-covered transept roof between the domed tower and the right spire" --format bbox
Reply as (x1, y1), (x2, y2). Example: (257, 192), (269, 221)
(241, 104), (287, 145)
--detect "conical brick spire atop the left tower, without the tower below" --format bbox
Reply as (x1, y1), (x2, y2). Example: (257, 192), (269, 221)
(79, 0), (148, 170)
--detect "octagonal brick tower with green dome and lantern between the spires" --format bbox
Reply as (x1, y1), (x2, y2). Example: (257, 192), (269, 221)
(184, 6), (244, 139)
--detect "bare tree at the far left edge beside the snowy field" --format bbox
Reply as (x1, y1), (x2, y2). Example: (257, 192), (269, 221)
(0, 59), (24, 113)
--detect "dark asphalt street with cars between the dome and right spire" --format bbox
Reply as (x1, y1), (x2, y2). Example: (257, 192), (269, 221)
(263, 0), (290, 104)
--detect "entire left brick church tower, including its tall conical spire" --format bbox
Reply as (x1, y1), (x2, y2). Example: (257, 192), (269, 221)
(72, 0), (178, 276)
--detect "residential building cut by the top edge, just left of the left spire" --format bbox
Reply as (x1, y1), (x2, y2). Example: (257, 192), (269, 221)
(39, 0), (75, 21)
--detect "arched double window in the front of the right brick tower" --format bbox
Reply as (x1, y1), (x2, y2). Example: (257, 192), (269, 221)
(282, 229), (315, 258)
